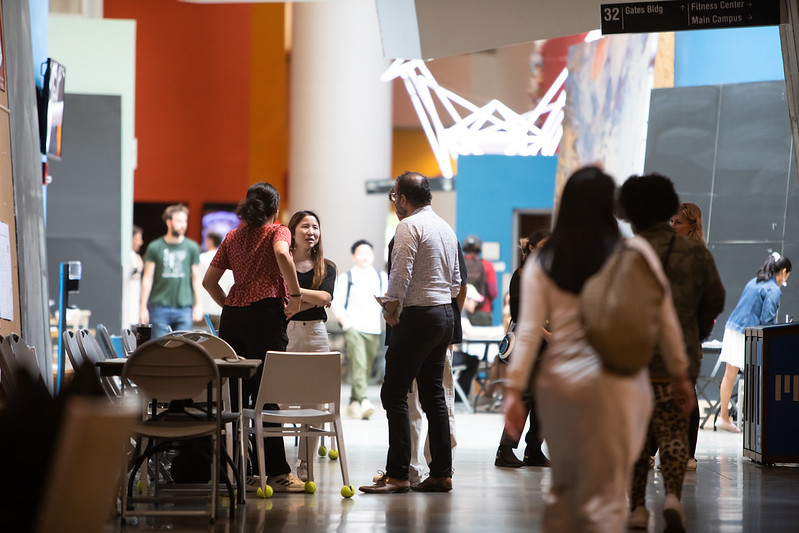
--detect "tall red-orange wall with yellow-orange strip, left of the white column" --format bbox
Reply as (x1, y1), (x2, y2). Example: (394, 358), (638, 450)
(104, 0), (288, 239)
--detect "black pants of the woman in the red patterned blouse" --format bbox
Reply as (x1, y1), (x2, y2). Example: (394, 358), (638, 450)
(219, 298), (291, 476)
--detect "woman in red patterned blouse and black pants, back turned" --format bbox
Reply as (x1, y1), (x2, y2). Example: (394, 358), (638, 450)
(203, 182), (305, 492)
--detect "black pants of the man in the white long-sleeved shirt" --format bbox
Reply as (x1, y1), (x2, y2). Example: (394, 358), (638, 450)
(380, 303), (454, 479)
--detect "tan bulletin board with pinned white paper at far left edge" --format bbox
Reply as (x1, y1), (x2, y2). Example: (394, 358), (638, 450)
(0, 6), (21, 336)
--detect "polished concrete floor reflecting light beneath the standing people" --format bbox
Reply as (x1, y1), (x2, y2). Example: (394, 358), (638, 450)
(106, 387), (799, 533)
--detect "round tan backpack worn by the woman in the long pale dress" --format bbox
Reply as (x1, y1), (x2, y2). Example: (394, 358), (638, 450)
(580, 241), (666, 376)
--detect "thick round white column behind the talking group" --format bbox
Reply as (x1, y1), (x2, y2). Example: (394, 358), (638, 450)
(292, 0), (392, 272)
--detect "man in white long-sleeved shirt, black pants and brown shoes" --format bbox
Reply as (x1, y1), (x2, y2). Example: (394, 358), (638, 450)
(360, 172), (461, 494)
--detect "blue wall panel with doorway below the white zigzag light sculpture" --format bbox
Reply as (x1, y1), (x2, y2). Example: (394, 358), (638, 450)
(456, 155), (558, 324)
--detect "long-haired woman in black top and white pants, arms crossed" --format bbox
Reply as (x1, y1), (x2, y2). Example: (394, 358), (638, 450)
(286, 211), (336, 481)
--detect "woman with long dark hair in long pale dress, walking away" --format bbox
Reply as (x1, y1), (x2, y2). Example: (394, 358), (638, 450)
(505, 167), (691, 533)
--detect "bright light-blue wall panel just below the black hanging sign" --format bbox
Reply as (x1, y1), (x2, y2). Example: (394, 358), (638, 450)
(674, 26), (785, 87)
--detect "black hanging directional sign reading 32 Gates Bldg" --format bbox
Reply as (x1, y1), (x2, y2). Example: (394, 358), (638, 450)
(600, 0), (780, 34)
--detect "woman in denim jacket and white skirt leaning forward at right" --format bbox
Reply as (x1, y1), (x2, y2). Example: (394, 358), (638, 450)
(716, 252), (791, 433)
